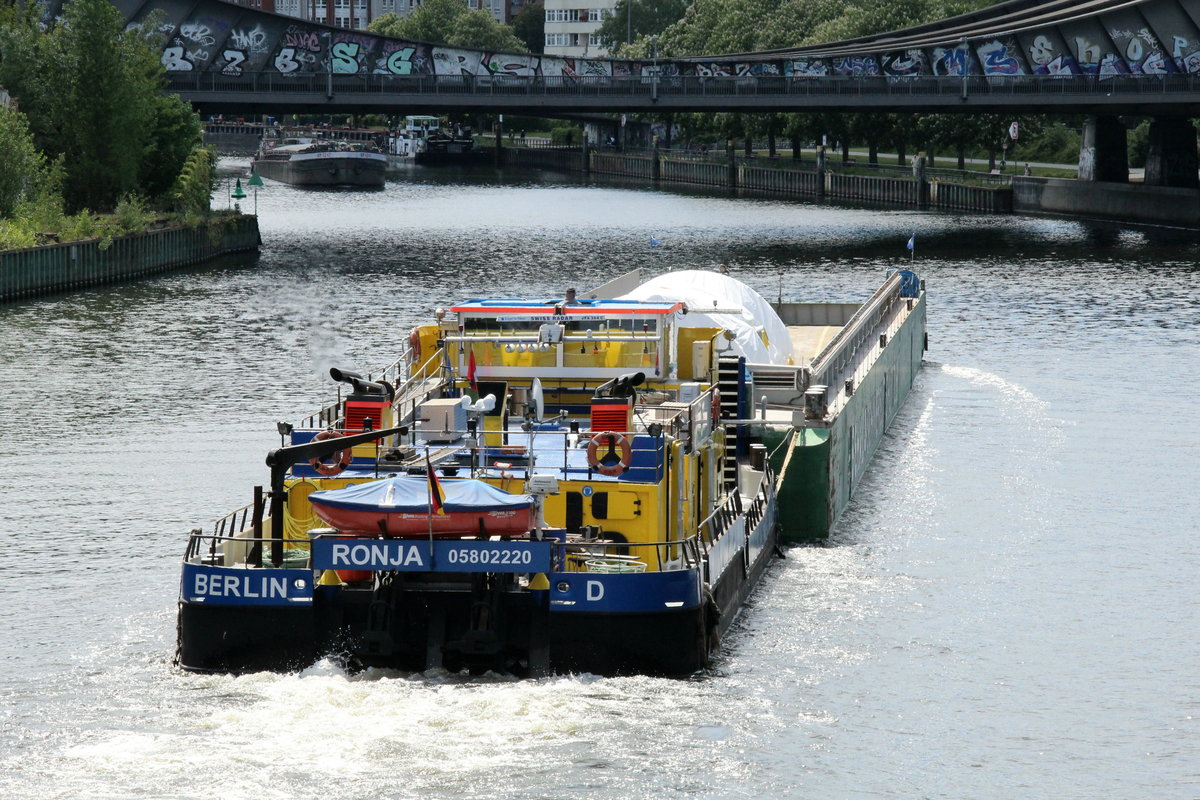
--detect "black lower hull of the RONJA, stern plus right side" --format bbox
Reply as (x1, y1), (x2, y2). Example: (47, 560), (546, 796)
(178, 496), (778, 676)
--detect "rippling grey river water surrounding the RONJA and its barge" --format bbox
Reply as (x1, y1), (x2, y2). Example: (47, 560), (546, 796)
(0, 162), (1200, 800)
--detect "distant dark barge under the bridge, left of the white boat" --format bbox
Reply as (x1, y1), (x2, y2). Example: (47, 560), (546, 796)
(251, 138), (388, 186)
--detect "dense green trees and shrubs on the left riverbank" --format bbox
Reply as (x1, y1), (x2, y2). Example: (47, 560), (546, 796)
(0, 0), (216, 249)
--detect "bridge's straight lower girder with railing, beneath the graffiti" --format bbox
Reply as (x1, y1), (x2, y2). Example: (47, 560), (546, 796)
(168, 71), (1200, 113)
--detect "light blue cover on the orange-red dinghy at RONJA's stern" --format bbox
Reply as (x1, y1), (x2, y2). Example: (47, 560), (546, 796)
(308, 475), (533, 513)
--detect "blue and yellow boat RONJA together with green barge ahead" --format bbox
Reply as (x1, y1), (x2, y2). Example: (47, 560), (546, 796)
(176, 271), (924, 675)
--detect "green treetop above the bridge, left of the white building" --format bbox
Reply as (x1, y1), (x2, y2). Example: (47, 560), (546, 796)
(367, 0), (527, 53)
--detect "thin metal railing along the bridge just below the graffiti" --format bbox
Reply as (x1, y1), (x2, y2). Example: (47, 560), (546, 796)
(168, 71), (1200, 97)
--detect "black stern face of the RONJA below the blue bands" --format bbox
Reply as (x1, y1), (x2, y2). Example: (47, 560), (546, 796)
(178, 591), (713, 675)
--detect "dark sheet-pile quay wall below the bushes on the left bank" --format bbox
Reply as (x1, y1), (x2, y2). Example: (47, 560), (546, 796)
(0, 216), (262, 302)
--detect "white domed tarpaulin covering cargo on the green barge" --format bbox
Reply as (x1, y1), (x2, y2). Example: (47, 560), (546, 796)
(619, 270), (792, 365)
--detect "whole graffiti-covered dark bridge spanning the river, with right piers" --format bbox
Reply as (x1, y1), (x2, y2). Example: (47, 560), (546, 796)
(63, 0), (1200, 186)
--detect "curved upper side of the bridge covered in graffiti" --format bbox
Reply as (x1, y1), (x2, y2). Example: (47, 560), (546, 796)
(152, 0), (1200, 86)
